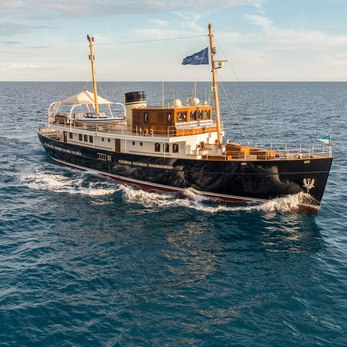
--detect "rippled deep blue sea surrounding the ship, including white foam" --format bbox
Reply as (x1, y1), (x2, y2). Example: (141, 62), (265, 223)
(0, 82), (347, 346)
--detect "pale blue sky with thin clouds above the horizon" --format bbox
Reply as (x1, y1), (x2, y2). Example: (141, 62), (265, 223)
(0, 0), (347, 81)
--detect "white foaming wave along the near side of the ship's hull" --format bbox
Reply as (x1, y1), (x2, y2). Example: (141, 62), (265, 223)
(20, 172), (310, 214)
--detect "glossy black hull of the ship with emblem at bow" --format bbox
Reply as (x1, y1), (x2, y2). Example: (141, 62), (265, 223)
(39, 133), (332, 208)
